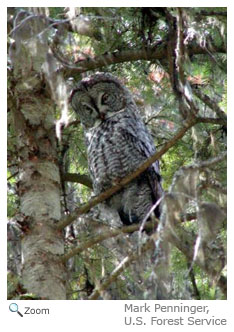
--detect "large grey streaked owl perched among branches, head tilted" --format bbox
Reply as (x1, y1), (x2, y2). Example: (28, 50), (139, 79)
(70, 73), (162, 225)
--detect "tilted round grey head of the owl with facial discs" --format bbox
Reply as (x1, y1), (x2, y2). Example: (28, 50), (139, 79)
(70, 73), (134, 128)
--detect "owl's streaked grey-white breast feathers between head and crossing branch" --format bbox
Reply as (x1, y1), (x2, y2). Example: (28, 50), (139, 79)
(86, 111), (162, 202)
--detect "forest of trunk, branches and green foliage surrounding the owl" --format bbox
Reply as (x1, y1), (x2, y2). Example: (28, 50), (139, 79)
(8, 7), (227, 299)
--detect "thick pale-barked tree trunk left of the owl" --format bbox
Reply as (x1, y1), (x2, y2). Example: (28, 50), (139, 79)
(8, 7), (66, 300)
